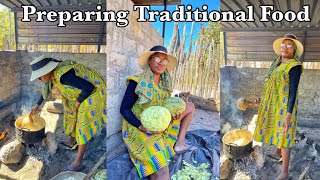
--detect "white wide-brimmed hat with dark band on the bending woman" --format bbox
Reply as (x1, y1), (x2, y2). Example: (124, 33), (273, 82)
(30, 55), (61, 81)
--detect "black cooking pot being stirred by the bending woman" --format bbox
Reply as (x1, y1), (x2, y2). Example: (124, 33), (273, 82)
(15, 115), (46, 144)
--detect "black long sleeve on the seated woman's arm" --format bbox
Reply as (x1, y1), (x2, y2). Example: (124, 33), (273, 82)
(120, 81), (141, 128)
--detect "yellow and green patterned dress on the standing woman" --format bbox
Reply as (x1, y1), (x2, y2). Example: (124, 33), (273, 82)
(254, 59), (303, 149)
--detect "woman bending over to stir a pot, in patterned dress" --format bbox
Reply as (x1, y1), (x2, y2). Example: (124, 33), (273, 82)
(30, 56), (106, 171)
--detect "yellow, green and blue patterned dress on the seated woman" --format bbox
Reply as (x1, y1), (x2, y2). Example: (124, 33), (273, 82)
(122, 67), (179, 178)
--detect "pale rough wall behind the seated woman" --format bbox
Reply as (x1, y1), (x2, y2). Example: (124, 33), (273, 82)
(107, 0), (163, 136)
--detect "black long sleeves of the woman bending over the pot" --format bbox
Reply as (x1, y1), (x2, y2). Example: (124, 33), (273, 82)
(37, 69), (94, 105)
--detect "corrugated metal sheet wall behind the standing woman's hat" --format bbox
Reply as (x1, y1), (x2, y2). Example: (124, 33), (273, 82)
(225, 31), (320, 62)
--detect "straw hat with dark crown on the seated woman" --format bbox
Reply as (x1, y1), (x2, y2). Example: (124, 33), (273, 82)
(138, 46), (178, 71)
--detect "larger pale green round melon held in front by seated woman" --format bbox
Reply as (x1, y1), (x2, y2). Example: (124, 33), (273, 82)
(141, 106), (171, 131)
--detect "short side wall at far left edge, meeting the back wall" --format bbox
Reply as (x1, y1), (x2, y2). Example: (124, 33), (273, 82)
(0, 51), (21, 120)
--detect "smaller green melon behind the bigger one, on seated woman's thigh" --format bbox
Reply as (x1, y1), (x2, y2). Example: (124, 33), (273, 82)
(163, 97), (186, 116)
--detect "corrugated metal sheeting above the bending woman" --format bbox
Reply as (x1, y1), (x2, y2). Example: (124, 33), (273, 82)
(0, 0), (106, 45)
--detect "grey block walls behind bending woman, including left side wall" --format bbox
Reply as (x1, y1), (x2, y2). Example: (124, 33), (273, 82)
(0, 51), (106, 119)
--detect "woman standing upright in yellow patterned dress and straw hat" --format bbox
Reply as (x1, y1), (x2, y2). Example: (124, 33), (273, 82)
(254, 34), (303, 180)
